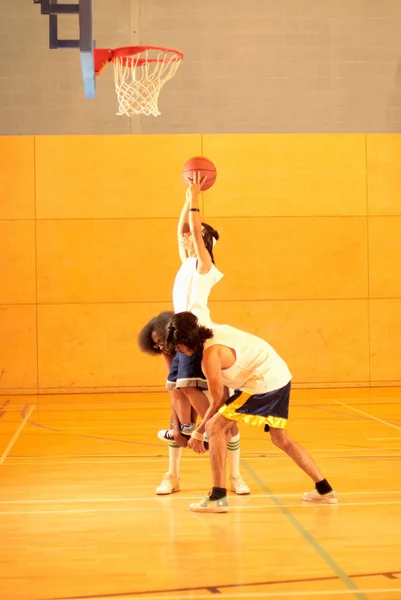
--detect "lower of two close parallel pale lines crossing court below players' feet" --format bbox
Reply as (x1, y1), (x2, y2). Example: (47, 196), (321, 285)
(0, 496), (401, 515)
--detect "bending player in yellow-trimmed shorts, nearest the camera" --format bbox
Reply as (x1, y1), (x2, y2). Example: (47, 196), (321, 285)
(166, 312), (337, 512)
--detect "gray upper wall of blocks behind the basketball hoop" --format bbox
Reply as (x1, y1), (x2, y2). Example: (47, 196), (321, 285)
(0, 0), (401, 135)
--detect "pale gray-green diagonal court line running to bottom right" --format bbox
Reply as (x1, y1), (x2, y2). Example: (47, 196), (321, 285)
(241, 460), (368, 600)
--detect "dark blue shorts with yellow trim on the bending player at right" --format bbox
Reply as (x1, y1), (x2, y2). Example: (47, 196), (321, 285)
(219, 381), (291, 431)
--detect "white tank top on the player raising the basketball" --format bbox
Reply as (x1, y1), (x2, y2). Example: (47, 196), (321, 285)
(173, 256), (223, 326)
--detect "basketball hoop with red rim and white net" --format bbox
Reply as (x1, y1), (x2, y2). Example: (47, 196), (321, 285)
(94, 46), (184, 117)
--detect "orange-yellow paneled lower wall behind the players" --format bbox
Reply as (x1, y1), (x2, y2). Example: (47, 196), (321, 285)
(0, 135), (401, 393)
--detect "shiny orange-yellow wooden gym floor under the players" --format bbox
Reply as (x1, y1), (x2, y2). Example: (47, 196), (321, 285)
(0, 389), (401, 600)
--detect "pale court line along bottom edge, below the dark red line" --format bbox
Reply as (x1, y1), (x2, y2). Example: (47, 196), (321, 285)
(44, 586), (401, 600)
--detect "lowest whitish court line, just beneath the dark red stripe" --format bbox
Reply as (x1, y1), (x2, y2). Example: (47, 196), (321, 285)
(28, 584), (401, 600)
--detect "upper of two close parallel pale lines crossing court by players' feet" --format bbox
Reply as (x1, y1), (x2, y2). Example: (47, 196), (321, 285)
(0, 490), (401, 505)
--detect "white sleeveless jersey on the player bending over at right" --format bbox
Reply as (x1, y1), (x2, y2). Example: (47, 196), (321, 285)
(204, 325), (291, 394)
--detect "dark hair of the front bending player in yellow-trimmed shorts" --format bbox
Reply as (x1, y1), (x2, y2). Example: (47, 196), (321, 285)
(166, 312), (213, 354)
